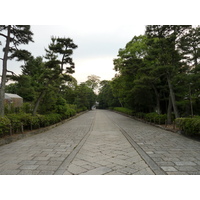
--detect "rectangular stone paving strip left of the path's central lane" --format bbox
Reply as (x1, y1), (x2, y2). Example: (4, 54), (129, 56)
(0, 112), (95, 175)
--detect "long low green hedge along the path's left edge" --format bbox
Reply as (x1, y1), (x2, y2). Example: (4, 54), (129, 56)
(0, 103), (87, 137)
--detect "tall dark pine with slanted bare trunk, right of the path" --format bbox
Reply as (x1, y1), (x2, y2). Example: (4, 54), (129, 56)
(146, 25), (191, 118)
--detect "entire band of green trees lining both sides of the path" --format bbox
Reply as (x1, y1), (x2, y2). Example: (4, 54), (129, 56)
(0, 25), (200, 123)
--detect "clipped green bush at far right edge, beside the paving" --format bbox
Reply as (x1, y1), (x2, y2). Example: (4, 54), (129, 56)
(175, 117), (200, 136)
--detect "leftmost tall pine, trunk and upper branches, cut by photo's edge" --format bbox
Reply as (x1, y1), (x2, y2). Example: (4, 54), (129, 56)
(0, 25), (33, 116)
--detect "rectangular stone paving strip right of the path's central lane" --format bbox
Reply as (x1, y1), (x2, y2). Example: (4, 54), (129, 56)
(106, 112), (200, 175)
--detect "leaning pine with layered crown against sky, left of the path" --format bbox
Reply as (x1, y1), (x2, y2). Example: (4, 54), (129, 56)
(33, 37), (77, 115)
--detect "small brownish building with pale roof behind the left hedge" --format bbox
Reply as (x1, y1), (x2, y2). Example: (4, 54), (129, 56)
(4, 93), (23, 108)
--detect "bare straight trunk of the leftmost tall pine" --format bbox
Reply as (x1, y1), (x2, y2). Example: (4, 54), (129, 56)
(0, 25), (11, 117)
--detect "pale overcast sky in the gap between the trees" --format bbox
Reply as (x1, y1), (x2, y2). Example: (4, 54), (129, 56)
(19, 23), (145, 82)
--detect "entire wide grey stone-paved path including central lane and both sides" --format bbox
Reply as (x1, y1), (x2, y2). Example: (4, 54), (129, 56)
(0, 110), (200, 175)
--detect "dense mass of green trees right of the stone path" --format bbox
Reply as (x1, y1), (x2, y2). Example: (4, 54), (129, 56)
(99, 25), (200, 123)
